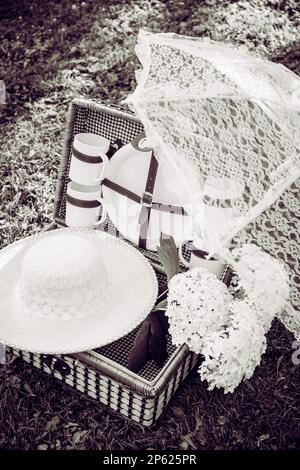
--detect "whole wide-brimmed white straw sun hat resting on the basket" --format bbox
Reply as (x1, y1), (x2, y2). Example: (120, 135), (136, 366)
(0, 228), (157, 354)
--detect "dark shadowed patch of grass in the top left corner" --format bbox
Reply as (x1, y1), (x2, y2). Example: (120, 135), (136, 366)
(0, 0), (130, 122)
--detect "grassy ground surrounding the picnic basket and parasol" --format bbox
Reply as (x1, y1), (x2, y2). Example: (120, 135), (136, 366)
(0, 0), (300, 449)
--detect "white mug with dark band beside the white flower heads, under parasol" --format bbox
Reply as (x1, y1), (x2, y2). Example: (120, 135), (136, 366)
(178, 239), (225, 278)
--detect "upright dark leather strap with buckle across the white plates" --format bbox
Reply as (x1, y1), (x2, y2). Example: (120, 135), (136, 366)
(139, 151), (158, 249)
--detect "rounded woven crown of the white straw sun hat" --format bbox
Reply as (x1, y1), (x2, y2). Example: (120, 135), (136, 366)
(20, 234), (109, 320)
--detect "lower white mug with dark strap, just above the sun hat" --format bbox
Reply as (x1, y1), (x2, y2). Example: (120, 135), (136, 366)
(66, 181), (107, 227)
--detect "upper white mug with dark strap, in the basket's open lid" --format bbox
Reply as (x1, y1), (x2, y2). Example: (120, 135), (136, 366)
(69, 133), (110, 185)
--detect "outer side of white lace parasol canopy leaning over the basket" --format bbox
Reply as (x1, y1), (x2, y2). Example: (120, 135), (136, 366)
(126, 31), (300, 255)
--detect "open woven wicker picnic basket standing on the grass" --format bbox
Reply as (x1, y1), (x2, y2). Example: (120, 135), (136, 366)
(10, 99), (211, 426)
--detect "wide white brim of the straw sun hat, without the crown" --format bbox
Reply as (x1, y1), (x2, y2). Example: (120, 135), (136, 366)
(0, 228), (158, 354)
